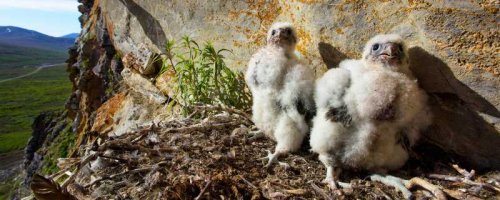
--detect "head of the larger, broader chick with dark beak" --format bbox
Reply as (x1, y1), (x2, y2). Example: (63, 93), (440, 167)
(363, 34), (408, 71)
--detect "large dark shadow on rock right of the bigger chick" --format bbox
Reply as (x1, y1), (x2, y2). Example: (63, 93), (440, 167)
(409, 47), (500, 170)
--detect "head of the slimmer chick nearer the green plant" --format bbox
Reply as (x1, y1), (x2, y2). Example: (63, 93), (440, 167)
(267, 22), (298, 50)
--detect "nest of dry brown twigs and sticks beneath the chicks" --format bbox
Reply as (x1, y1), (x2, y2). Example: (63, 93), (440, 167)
(32, 106), (500, 199)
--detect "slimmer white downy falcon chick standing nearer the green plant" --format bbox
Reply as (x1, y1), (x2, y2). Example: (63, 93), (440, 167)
(245, 22), (315, 167)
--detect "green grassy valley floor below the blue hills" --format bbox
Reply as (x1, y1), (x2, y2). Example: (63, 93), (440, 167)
(0, 65), (71, 153)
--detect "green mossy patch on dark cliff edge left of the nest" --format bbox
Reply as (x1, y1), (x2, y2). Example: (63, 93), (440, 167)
(42, 125), (76, 175)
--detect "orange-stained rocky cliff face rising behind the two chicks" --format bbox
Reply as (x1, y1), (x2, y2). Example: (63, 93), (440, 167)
(67, 0), (500, 171)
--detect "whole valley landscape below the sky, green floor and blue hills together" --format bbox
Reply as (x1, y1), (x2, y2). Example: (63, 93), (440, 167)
(0, 26), (78, 153)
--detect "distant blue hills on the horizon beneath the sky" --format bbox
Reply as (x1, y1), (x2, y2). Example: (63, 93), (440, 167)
(0, 26), (75, 52)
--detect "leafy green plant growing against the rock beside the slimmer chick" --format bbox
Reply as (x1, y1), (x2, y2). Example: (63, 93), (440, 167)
(159, 36), (251, 115)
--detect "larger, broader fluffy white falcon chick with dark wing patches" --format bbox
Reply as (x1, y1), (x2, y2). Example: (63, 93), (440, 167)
(310, 34), (430, 192)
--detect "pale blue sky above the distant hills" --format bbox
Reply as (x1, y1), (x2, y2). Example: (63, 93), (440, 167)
(0, 0), (80, 37)
